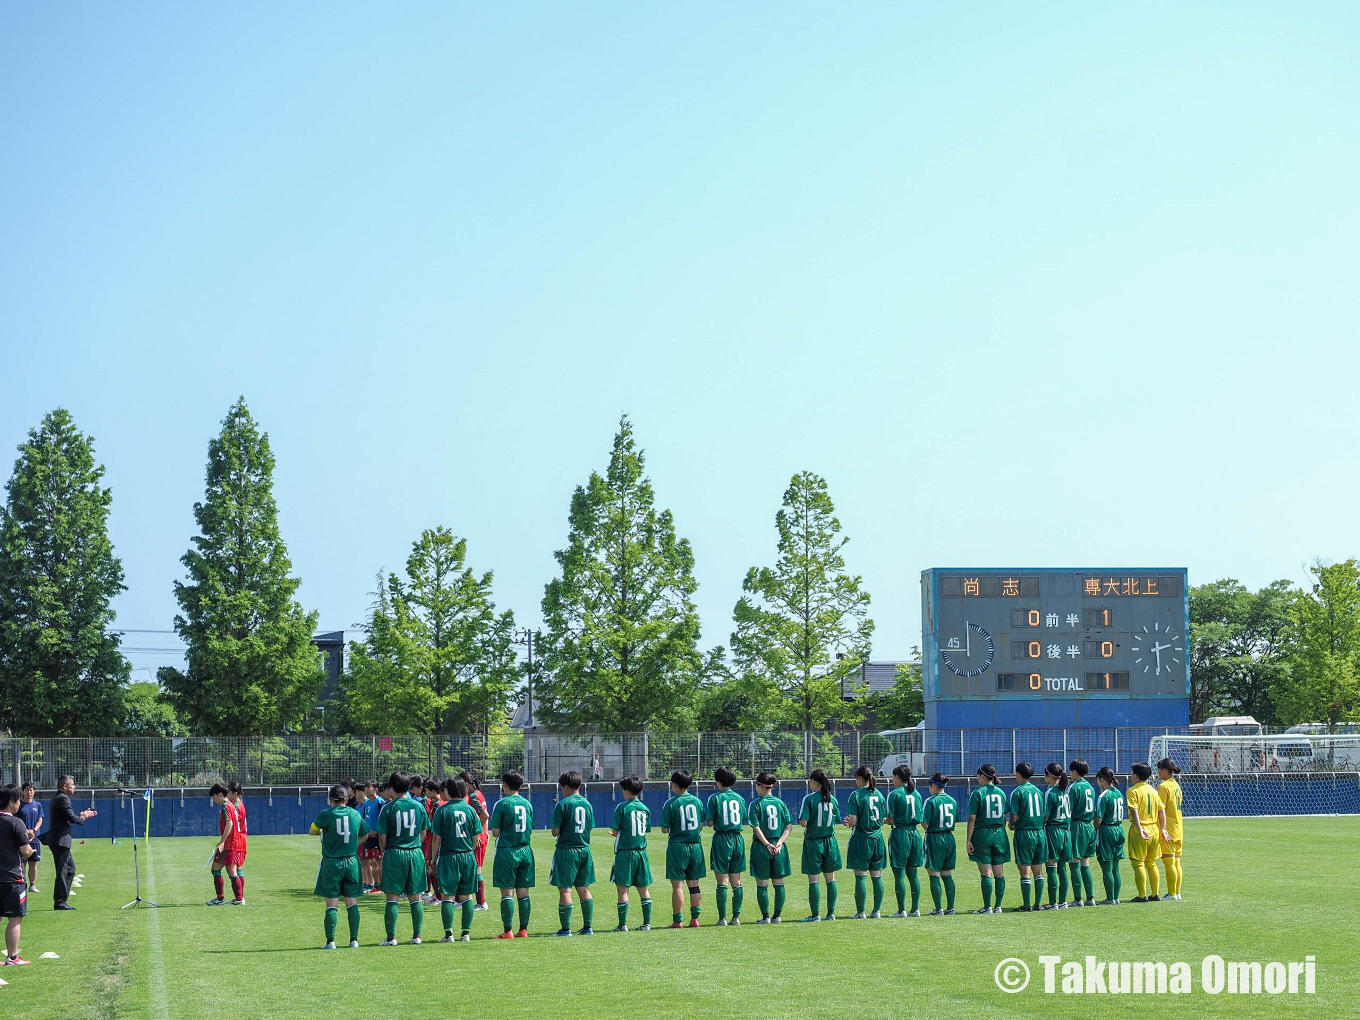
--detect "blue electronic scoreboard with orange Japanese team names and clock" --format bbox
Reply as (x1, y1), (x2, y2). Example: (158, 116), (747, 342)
(921, 567), (1190, 728)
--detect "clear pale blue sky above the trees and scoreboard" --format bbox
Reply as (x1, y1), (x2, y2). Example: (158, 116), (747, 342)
(0, 3), (1360, 679)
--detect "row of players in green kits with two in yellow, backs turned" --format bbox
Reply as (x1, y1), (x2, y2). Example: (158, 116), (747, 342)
(303, 759), (1182, 948)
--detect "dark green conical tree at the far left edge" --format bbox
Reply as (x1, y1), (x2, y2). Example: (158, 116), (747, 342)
(0, 408), (131, 737)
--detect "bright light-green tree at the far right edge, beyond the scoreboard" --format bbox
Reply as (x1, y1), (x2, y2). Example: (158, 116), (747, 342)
(1276, 559), (1360, 725)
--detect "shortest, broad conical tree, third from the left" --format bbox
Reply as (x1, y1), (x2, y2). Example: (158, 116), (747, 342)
(340, 528), (518, 733)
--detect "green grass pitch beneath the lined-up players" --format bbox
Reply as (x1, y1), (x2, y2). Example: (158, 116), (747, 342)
(0, 817), (1360, 1020)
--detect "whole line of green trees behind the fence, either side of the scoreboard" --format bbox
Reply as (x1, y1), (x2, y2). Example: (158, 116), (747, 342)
(0, 398), (1360, 736)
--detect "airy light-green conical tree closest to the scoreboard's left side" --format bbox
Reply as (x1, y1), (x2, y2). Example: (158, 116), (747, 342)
(732, 471), (873, 729)
